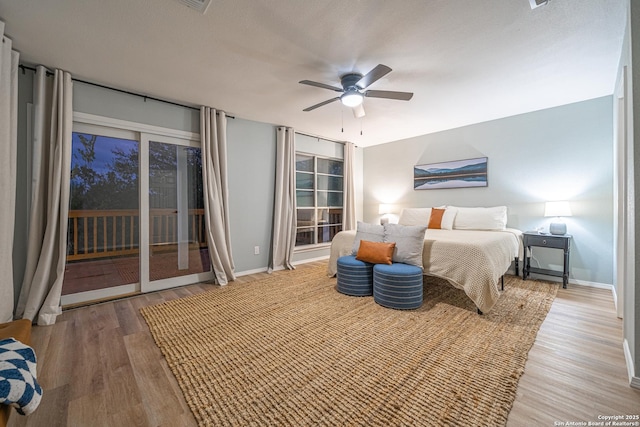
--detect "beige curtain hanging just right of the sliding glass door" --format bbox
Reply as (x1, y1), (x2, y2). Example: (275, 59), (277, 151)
(200, 107), (236, 285)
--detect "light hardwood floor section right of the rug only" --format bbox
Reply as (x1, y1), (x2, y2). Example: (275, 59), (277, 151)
(508, 285), (640, 427)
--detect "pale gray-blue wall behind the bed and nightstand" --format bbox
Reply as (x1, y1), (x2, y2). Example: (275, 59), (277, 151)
(363, 96), (613, 285)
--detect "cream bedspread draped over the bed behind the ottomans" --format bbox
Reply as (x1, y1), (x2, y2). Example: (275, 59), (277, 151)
(327, 228), (522, 313)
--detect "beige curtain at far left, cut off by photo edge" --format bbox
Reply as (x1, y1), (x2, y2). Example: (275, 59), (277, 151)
(0, 21), (20, 323)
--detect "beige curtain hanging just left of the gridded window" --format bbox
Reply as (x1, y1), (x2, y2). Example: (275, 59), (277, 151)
(268, 127), (296, 273)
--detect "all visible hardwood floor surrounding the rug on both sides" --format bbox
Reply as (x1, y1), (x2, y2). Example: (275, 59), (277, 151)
(9, 262), (640, 427)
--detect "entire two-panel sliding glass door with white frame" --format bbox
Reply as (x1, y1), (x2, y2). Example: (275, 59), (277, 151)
(62, 124), (213, 305)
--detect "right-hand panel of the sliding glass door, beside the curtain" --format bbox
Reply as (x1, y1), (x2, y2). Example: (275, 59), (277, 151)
(142, 135), (211, 291)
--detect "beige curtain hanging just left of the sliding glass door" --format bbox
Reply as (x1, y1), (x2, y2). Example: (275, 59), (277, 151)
(16, 66), (73, 325)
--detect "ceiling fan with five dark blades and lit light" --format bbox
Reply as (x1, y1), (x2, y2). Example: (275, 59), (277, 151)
(299, 64), (413, 118)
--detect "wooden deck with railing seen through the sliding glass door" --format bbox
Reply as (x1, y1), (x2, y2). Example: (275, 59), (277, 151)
(62, 208), (210, 295)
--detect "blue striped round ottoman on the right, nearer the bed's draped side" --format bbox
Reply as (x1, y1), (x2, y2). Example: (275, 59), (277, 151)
(373, 263), (422, 310)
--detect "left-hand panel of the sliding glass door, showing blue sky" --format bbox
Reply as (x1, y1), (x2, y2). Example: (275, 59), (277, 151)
(62, 124), (140, 304)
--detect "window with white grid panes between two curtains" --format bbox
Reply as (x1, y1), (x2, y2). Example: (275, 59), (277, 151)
(296, 153), (344, 247)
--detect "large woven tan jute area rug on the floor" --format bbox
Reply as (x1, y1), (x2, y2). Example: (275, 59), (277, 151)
(141, 266), (558, 426)
